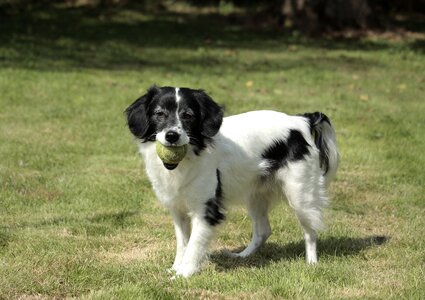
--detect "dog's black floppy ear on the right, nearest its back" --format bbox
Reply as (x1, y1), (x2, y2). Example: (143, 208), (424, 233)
(196, 90), (223, 137)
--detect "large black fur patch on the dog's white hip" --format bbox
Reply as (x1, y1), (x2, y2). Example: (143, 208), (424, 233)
(262, 129), (310, 174)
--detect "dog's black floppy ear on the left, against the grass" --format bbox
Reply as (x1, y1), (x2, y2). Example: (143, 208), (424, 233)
(124, 86), (159, 139)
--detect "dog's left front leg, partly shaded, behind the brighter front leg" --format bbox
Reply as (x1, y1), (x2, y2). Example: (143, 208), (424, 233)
(171, 210), (190, 271)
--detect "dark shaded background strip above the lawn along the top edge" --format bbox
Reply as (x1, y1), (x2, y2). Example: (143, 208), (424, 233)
(0, 0), (425, 34)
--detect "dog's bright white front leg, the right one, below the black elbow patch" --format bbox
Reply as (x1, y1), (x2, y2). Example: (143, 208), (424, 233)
(177, 214), (214, 277)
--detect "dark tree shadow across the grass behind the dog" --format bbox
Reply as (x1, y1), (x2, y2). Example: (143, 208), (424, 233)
(0, 7), (416, 72)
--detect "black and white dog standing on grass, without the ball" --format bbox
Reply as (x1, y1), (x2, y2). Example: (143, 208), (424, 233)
(125, 87), (338, 277)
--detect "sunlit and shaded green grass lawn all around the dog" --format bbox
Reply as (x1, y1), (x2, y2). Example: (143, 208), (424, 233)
(0, 5), (425, 299)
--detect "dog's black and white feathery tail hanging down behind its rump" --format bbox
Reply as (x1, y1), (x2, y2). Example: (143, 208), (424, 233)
(303, 112), (339, 184)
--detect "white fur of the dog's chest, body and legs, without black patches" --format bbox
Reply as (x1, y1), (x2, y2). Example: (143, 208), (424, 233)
(136, 109), (338, 277)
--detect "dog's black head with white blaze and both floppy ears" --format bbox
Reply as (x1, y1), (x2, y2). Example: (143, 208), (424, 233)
(125, 86), (223, 165)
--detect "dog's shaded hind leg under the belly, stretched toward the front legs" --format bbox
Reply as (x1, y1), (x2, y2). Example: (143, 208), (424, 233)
(230, 199), (272, 257)
